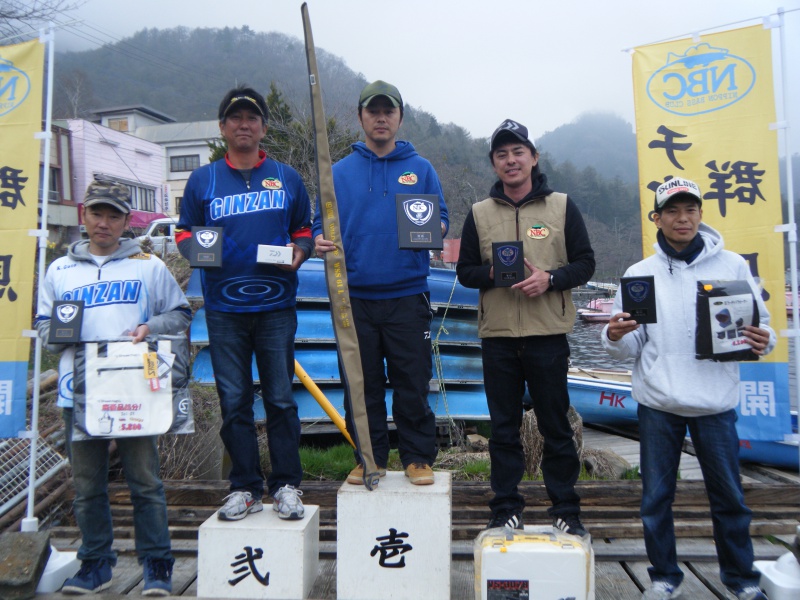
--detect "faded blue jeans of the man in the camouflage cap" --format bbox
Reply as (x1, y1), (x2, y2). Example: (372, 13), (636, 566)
(63, 408), (172, 565)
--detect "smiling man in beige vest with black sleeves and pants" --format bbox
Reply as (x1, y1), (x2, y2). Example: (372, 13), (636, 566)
(457, 119), (595, 536)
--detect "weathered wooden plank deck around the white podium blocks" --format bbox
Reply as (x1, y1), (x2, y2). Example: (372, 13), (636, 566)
(31, 428), (800, 600)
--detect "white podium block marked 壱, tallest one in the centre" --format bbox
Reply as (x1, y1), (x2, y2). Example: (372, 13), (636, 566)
(336, 472), (452, 600)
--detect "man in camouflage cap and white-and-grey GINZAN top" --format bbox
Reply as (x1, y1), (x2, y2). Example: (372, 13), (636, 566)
(35, 180), (191, 596)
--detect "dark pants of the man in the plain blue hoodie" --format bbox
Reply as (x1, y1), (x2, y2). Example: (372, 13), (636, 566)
(345, 294), (436, 467)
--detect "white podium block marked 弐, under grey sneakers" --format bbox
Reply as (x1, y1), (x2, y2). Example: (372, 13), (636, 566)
(197, 502), (319, 600)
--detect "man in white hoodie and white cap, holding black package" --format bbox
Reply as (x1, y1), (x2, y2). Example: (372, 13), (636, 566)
(601, 179), (776, 600)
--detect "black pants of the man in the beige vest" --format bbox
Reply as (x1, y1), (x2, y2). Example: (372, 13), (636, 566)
(482, 335), (581, 516)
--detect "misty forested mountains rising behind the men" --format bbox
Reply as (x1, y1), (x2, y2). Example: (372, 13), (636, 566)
(54, 26), (641, 278)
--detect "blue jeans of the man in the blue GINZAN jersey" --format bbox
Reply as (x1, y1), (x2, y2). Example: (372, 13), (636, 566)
(206, 308), (303, 498)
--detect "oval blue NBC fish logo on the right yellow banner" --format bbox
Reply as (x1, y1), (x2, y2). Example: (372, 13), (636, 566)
(647, 43), (756, 117)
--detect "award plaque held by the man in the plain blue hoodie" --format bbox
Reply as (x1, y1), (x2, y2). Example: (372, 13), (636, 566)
(395, 194), (444, 250)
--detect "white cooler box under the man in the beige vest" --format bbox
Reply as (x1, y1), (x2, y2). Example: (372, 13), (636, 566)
(474, 527), (594, 600)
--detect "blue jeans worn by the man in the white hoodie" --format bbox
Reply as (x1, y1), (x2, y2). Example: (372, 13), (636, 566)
(639, 404), (759, 590)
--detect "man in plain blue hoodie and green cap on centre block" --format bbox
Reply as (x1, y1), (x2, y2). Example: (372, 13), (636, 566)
(312, 81), (448, 485)
